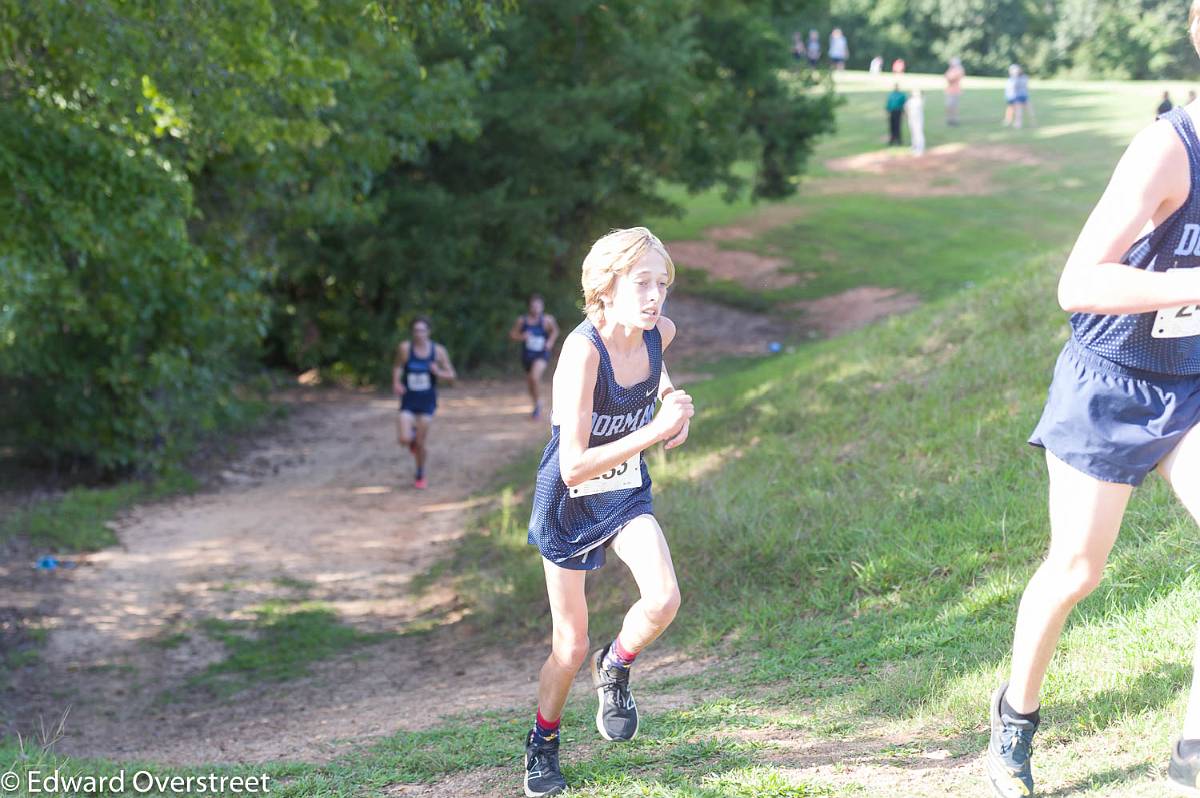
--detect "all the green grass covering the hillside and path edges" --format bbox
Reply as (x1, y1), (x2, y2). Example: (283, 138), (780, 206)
(14, 69), (1200, 798)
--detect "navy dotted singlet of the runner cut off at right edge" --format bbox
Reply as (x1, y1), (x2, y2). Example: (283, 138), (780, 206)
(1070, 108), (1200, 377)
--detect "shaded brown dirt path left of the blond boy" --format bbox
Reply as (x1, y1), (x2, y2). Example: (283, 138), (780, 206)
(0, 382), (566, 762)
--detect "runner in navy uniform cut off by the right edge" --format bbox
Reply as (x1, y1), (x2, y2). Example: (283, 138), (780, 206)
(988, 10), (1200, 798)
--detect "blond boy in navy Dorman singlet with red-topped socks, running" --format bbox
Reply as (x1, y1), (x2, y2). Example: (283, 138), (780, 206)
(524, 227), (692, 798)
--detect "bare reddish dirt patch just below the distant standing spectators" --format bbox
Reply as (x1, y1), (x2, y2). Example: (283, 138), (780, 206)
(825, 142), (1042, 197)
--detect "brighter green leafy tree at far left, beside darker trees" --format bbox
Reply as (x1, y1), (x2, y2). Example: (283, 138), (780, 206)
(0, 0), (501, 469)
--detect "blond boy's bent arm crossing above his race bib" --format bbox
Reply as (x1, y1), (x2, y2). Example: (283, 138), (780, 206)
(553, 335), (690, 487)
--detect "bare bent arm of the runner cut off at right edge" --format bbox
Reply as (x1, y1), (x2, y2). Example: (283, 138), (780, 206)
(1058, 122), (1200, 314)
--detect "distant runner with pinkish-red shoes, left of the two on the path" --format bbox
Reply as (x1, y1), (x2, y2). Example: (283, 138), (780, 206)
(391, 318), (455, 490)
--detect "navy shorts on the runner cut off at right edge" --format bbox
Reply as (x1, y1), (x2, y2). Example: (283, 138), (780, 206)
(1030, 338), (1200, 485)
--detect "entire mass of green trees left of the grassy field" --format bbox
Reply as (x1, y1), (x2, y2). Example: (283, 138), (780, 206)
(0, 0), (833, 469)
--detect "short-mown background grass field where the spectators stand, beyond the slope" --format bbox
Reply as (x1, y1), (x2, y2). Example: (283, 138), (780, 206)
(650, 73), (1184, 312)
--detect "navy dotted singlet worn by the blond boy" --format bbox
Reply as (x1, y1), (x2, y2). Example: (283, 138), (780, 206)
(529, 320), (662, 570)
